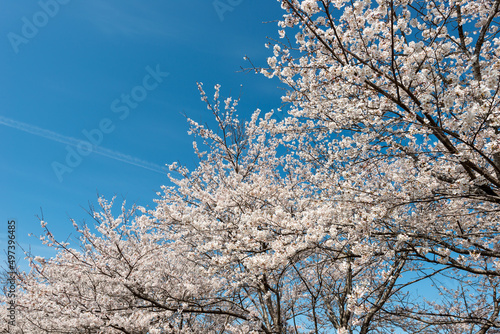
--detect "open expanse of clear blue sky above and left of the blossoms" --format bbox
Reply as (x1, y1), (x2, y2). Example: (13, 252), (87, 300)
(0, 0), (282, 262)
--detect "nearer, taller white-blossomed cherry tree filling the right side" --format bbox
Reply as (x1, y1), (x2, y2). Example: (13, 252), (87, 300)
(262, 0), (500, 333)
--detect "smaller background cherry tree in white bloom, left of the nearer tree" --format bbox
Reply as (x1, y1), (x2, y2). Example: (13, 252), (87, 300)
(0, 86), (422, 333)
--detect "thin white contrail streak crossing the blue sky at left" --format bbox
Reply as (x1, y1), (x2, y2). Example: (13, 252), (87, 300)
(0, 116), (166, 174)
